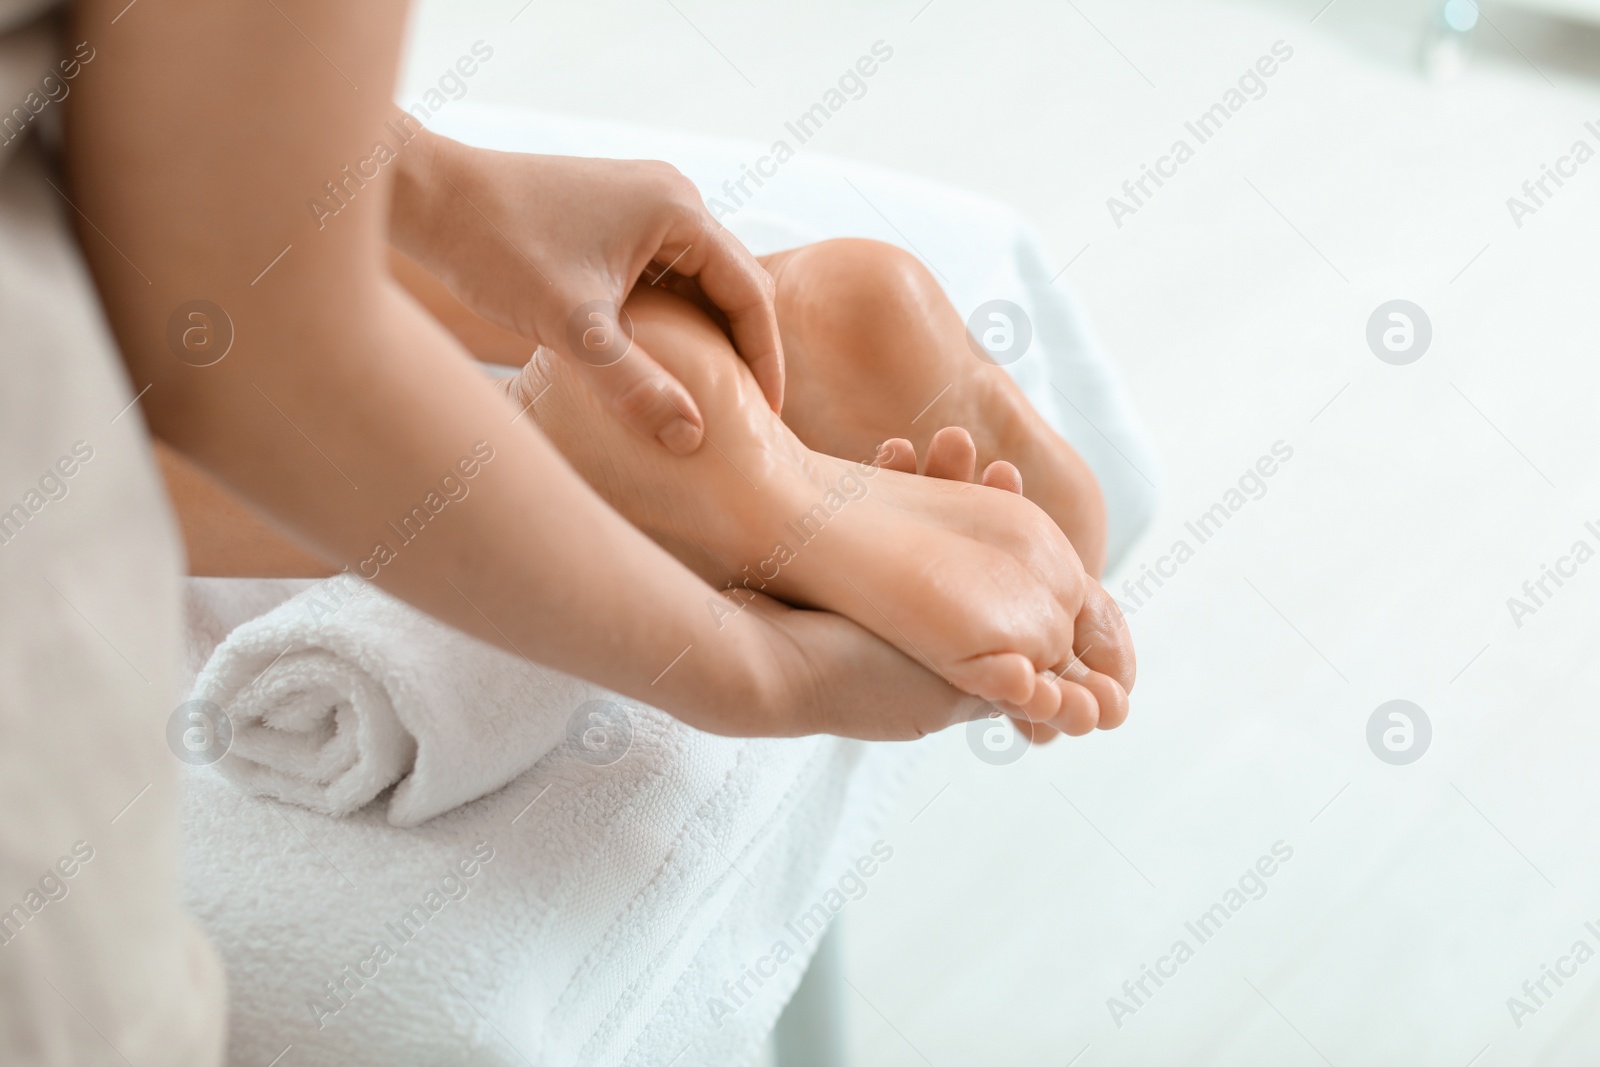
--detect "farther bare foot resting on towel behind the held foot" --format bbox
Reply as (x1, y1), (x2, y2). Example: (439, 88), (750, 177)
(762, 238), (1106, 577)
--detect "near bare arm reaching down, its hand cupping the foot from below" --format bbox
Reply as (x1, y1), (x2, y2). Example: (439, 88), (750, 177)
(67, 0), (957, 733)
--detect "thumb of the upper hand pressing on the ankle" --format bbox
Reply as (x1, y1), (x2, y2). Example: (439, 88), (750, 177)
(552, 301), (706, 456)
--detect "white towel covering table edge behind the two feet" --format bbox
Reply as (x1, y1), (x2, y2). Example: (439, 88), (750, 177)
(430, 101), (1160, 571)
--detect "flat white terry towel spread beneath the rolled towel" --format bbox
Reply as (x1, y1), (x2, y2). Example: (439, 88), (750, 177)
(184, 579), (918, 1067)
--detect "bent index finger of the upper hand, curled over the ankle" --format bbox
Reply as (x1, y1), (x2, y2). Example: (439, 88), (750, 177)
(654, 219), (784, 411)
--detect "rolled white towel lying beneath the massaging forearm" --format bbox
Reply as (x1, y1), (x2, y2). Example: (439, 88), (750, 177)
(190, 576), (601, 827)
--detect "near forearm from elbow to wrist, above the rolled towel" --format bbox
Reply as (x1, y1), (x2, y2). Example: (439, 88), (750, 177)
(139, 268), (764, 721)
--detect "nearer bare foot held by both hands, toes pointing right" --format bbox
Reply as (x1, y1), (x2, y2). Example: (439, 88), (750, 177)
(509, 288), (1133, 733)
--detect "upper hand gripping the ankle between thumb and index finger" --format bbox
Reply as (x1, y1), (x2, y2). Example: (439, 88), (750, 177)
(389, 131), (784, 454)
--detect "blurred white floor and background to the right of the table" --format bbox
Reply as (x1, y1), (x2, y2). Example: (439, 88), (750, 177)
(402, 0), (1600, 1067)
